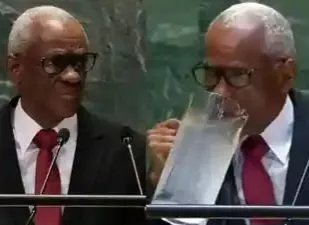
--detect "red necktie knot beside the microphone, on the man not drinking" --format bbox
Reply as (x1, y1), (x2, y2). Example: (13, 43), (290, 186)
(33, 129), (58, 151)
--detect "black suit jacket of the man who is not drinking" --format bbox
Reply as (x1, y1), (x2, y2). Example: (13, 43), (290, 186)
(0, 98), (145, 225)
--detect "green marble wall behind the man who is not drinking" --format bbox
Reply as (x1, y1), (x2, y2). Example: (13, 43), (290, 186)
(0, 0), (146, 130)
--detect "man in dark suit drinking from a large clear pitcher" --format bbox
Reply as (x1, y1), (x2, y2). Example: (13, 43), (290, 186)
(148, 2), (309, 225)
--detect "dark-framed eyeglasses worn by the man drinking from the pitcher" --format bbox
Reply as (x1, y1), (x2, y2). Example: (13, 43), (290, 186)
(192, 61), (254, 90)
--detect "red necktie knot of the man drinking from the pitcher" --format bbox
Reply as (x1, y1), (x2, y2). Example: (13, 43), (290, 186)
(241, 135), (268, 161)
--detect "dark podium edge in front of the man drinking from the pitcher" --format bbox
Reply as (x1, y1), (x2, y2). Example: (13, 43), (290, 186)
(146, 204), (309, 221)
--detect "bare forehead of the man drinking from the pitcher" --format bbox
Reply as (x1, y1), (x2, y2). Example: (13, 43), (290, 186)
(205, 21), (265, 67)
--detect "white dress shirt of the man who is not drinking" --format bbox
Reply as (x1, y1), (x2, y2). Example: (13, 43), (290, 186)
(12, 100), (77, 194)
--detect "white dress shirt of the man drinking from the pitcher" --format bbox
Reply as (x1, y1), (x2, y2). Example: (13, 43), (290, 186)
(164, 97), (294, 225)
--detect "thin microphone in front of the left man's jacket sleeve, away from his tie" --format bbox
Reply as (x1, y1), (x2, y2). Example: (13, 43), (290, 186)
(121, 126), (143, 195)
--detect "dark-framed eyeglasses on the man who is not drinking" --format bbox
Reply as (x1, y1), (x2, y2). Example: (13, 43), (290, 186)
(41, 52), (98, 75)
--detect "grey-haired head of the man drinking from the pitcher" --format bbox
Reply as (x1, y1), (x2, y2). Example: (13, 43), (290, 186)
(196, 2), (296, 134)
